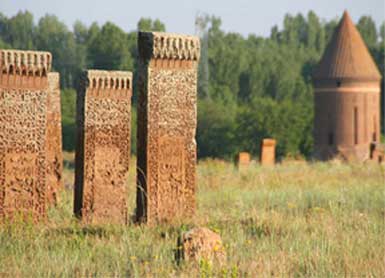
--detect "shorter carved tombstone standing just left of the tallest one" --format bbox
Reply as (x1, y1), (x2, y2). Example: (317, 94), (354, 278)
(74, 70), (132, 224)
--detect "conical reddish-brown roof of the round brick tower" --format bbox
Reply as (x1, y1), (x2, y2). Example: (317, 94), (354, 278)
(314, 11), (381, 80)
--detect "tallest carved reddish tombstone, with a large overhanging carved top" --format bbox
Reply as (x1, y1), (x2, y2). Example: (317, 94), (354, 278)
(136, 32), (200, 223)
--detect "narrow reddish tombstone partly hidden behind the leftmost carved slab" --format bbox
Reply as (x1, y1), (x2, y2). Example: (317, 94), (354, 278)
(46, 72), (63, 204)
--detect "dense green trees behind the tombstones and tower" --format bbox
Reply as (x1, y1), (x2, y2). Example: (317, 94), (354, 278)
(0, 12), (385, 158)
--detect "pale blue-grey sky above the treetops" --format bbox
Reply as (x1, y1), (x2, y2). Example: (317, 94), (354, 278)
(0, 0), (385, 36)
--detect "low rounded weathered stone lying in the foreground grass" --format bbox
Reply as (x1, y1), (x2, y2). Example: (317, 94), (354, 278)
(177, 228), (226, 265)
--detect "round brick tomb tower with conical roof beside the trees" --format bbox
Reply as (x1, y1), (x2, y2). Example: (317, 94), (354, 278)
(314, 11), (381, 161)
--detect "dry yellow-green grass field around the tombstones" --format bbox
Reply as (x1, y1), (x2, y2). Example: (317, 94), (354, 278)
(0, 154), (385, 277)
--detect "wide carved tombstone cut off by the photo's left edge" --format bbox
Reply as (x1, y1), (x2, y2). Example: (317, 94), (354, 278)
(0, 50), (51, 221)
